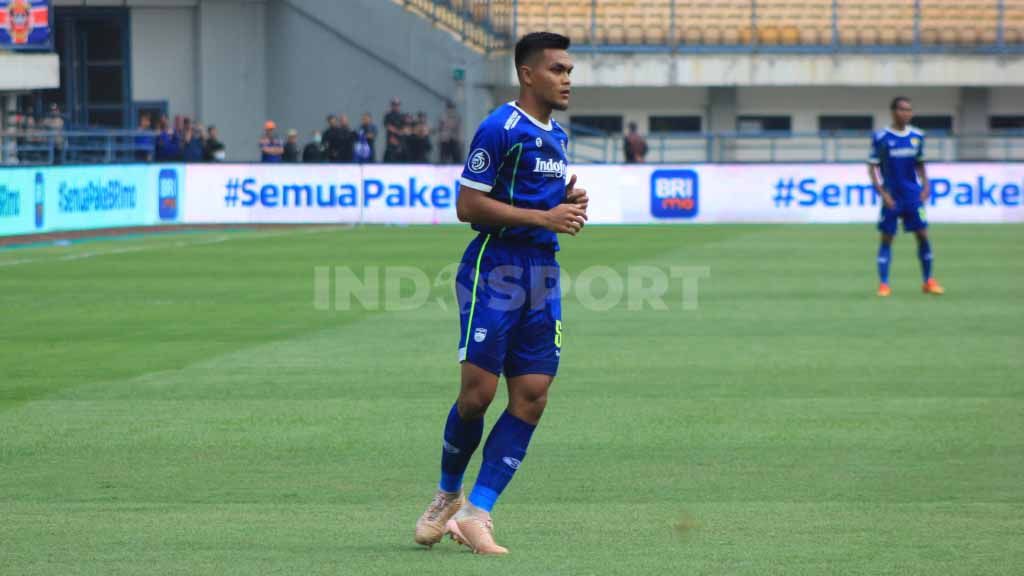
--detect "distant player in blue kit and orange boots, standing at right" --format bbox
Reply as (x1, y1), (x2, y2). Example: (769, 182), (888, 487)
(867, 96), (944, 296)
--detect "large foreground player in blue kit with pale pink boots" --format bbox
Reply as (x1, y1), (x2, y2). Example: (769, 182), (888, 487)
(416, 32), (588, 554)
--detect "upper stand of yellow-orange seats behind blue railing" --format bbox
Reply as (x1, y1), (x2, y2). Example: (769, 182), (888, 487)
(394, 0), (1024, 53)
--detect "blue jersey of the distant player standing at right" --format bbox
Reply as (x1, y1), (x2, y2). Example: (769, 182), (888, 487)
(867, 126), (925, 207)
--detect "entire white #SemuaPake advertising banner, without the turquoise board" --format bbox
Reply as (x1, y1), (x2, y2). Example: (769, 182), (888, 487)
(172, 163), (1024, 223)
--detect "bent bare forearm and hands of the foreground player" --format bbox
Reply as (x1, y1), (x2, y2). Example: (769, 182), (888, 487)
(455, 186), (587, 236)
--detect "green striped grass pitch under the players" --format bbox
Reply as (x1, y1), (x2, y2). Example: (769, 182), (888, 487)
(0, 224), (1024, 576)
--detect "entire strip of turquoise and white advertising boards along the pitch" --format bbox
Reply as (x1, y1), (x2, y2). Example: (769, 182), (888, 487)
(0, 163), (1024, 236)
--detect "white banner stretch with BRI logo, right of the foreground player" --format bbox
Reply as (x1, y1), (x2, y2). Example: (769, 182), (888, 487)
(569, 163), (1024, 223)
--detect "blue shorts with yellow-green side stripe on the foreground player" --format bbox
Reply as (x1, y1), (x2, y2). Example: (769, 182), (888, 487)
(456, 234), (562, 377)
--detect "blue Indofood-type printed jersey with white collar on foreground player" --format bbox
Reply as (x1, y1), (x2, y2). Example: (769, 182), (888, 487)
(460, 102), (569, 250)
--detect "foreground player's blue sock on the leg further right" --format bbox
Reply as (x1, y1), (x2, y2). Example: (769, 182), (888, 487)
(469, 411), (537, 512)
